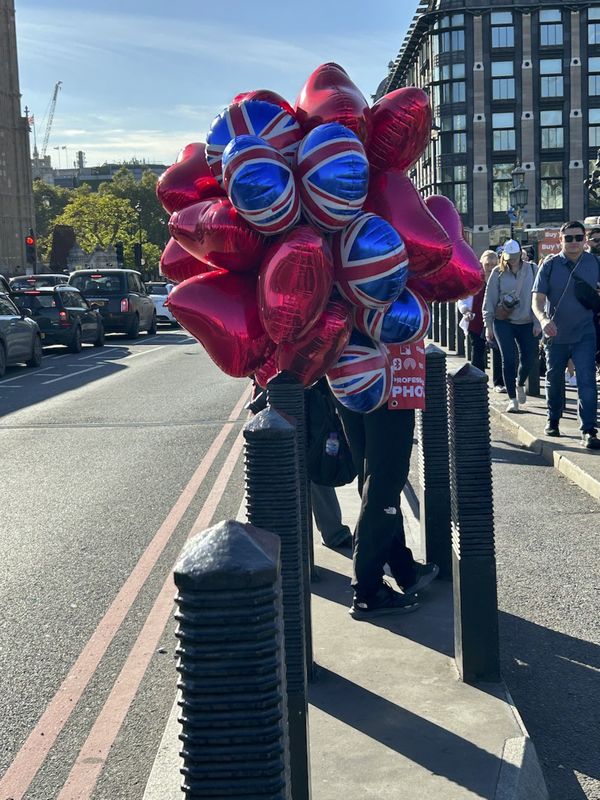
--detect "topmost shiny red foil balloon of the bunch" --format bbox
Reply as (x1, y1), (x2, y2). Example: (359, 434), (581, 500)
(295, 63), (371, 144)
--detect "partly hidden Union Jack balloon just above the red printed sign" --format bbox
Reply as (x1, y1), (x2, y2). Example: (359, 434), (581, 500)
(354, 289), (429, 344)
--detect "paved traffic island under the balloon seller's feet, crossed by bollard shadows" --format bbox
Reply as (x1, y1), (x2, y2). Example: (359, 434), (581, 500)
(144, 486), (548, 800)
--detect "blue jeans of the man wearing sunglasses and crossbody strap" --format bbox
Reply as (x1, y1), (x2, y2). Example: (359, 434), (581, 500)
(546, 336), (598, 431)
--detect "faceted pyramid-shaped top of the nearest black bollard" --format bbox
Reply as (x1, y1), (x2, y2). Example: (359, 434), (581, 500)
(174, 520), (280, 592)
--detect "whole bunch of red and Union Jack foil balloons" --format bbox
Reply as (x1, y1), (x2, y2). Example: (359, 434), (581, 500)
(157, 63), (483, 413)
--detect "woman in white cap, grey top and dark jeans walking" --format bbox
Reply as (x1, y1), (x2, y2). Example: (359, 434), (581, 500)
(483, 239), (540, 413)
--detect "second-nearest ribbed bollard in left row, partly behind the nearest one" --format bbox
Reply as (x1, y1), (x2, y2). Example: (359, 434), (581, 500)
(244, 407), (310, 800)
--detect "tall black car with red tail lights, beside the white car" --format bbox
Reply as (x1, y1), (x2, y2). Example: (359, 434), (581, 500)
(69, 269), (156, 339)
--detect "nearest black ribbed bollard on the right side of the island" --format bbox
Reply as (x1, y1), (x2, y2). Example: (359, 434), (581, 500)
(448, 364), (500, 683)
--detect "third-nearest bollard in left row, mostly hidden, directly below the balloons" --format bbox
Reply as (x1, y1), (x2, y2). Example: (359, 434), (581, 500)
(267, 372), (314, 680)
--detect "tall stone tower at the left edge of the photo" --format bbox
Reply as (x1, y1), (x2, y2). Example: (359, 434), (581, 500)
(0, 0), (35, 275)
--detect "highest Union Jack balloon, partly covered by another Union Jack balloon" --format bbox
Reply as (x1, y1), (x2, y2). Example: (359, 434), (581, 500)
(206, 100), (302, 184)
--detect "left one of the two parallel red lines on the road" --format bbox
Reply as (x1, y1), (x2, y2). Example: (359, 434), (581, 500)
(0, 387), (251, 800)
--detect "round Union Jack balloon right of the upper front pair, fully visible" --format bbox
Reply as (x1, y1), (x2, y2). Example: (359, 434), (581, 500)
(295, 122), (369, 231)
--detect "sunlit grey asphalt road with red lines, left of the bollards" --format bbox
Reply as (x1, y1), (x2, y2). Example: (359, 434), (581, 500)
(0, 332), (248, 800)
